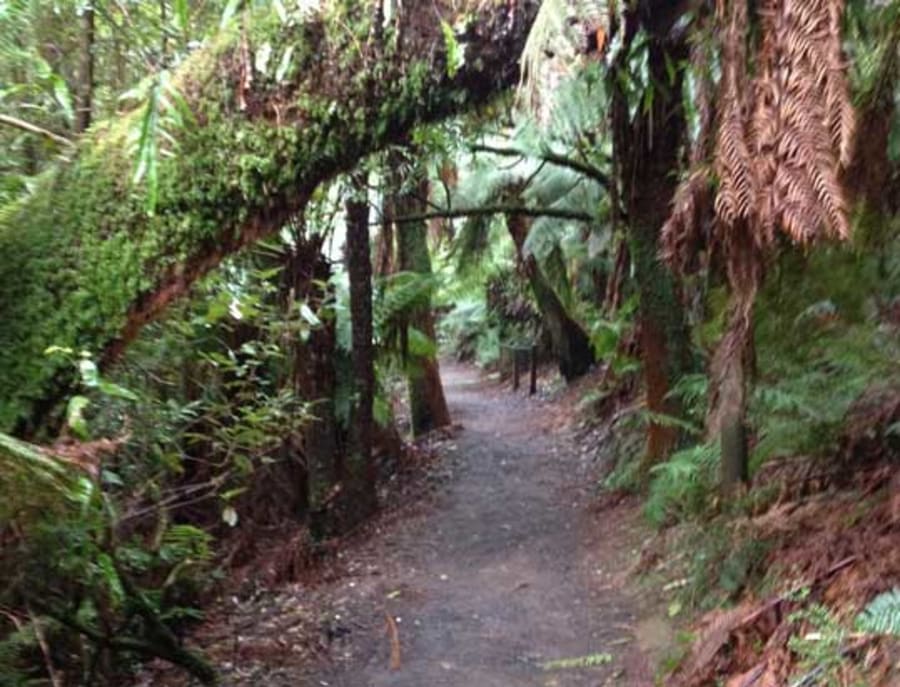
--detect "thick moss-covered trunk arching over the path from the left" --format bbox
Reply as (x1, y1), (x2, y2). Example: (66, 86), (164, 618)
(0, 0), (538, 433)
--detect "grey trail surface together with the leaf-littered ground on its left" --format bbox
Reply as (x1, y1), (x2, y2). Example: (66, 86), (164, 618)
(139, 364), (656, 687)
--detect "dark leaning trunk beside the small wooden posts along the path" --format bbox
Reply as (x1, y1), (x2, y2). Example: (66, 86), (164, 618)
(506, 215), (595, 382)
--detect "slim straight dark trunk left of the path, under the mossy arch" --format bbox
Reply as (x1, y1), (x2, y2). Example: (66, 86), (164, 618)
(341, 174), (377, 527)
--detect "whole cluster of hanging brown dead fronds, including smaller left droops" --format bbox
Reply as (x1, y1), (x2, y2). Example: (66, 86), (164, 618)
(664, 0), (855, 285)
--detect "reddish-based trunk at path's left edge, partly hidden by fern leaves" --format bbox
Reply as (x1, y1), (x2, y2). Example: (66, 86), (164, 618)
(394, 178), (450, 436)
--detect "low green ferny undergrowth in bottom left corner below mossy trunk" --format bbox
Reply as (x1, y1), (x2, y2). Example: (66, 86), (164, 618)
(0, 438), (212, 685)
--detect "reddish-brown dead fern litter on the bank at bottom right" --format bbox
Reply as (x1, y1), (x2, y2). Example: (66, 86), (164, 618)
(660, 392), (900, 687)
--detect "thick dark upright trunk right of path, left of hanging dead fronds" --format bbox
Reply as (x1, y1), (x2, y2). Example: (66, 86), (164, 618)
(610, 29), (690, 474)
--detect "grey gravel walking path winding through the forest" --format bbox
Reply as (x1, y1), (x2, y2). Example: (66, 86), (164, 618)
(308, 364), (652, 687)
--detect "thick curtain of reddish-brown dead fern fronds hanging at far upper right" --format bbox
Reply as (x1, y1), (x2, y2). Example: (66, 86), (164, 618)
(748, 0), (855, 245)
